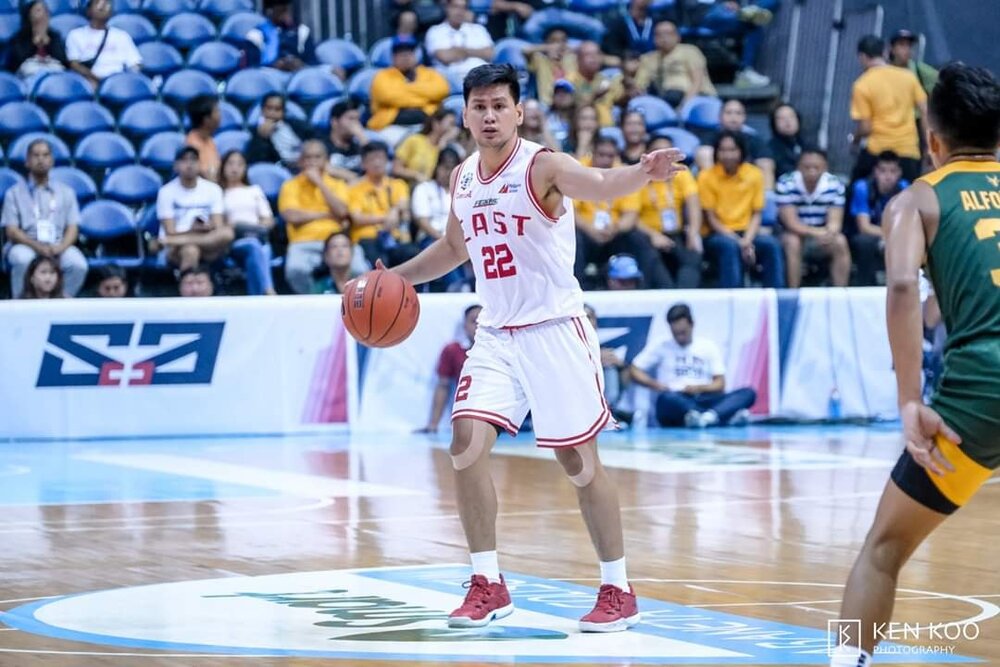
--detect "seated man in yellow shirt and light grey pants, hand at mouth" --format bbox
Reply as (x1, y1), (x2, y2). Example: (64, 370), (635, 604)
(278, 139), (350, 294)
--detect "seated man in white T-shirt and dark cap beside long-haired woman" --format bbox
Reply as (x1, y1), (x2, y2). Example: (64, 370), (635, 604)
(156, 146), (233, 272)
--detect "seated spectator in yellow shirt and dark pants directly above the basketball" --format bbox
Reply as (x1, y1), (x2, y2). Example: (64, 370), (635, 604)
(347, 141), (417, 266)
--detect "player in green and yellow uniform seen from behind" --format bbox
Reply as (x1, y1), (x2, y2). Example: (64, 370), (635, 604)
(831, 63), (1000, 667)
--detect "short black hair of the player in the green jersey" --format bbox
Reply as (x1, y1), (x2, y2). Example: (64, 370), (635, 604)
(928, 62), (1000, 153)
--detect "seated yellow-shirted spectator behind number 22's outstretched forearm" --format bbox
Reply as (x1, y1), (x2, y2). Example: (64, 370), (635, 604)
(573, 137), (670, 289)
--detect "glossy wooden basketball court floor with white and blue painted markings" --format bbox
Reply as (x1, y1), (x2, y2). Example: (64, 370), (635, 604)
(0, 427), (1000, 667)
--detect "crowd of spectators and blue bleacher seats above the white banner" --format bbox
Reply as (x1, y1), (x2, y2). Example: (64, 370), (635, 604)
(0, 0), (933, 296)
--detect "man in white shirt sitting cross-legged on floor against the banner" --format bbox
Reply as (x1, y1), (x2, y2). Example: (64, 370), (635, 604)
(630, 303), (757, 428)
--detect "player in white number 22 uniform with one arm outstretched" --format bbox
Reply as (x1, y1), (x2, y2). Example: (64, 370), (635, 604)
(382, 65), (683, 632)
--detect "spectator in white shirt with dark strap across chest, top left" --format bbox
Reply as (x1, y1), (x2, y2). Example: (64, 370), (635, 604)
(66, 0), (142, 86)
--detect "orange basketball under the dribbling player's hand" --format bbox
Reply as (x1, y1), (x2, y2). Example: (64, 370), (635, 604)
(340, 271), (420, 347)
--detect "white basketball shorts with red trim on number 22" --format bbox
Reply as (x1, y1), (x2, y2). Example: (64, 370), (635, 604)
(451, 317), (617, 447)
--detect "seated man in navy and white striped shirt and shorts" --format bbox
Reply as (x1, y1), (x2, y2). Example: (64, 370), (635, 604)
(775, 147), (851, 288)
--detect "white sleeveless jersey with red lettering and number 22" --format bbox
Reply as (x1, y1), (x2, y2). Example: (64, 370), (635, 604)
(452, 138), (584, 328)
